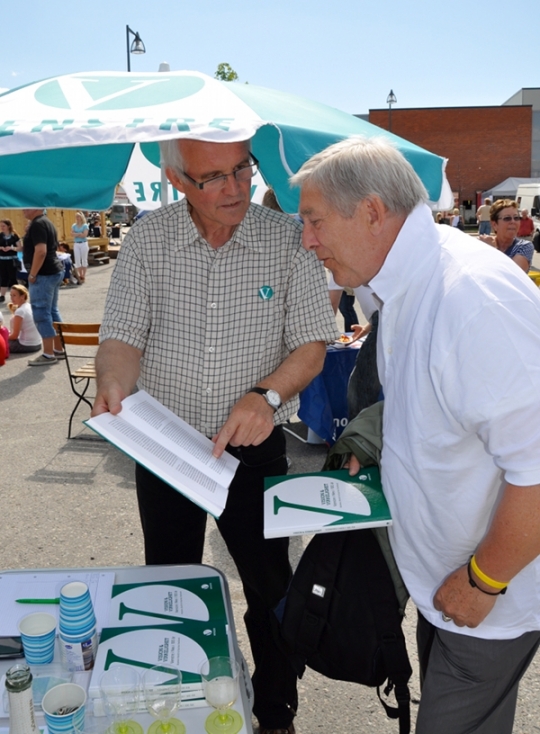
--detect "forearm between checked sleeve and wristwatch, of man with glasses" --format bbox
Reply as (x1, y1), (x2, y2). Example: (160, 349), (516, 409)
(258, 342), (326, 402)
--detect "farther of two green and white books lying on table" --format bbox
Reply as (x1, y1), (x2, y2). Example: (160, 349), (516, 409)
(109, 576), (227, 627)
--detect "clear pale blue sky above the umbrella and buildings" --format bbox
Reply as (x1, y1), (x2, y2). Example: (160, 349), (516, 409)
(4, 0), (540, 113)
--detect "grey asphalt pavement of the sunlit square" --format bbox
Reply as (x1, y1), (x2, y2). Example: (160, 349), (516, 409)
(0, 255), (540, 734)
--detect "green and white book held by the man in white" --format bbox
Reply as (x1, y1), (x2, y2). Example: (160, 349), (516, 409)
(264, 466), (392, 538)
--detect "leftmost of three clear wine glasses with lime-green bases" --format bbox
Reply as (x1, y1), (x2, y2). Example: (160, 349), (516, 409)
(99, 663), (144, 734)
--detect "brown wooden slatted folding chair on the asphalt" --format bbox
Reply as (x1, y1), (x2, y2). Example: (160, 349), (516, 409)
(54, 322), (100, 438)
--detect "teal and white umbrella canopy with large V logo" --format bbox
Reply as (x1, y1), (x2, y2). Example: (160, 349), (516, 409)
(0, 71), (445, 212)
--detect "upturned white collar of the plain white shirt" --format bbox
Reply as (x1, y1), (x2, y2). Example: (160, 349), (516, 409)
(369, 204), (443, 310)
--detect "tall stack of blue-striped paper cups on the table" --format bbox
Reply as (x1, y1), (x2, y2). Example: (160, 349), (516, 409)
(58, 581), (97, 670)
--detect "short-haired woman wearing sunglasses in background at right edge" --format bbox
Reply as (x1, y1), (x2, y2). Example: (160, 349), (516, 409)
(478, 199), (534, 273)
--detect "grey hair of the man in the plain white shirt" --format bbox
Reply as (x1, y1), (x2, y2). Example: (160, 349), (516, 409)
(290, 135), (428, 219)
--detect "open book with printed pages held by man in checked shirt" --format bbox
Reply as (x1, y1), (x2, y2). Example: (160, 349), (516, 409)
(84, 390), (239, 517)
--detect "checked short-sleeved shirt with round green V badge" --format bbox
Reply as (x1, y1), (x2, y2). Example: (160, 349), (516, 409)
(100, 199), (337, 436)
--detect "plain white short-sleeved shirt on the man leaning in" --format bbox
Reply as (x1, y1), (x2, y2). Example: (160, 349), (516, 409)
(370, 205), (540, 639)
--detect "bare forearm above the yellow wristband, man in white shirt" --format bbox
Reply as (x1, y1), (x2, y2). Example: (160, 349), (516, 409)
(476, 484), (540, 582)
